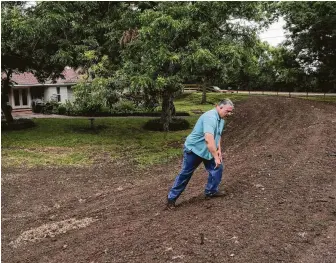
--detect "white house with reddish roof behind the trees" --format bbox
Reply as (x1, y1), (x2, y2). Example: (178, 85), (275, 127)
(4, 67), (79, 111)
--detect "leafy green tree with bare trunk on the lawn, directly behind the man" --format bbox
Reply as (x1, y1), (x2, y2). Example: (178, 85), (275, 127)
(122, 2), (189, 130)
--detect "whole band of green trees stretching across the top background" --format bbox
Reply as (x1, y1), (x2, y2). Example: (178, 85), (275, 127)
(1, 1), (336, 129)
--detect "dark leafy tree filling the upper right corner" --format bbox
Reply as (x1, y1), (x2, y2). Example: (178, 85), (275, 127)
(281, 1), (336, 92)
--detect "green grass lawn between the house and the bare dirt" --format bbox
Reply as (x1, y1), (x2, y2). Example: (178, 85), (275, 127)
(1, 93), (247, 167)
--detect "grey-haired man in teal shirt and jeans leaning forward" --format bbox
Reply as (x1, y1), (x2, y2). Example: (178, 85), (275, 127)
(167, 99), (234, 208)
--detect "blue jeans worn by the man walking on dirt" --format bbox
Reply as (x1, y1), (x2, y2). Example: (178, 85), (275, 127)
(168, 147), (224, 200)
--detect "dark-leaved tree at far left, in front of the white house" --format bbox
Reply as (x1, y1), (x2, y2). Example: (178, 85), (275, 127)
(1, 2), (72, 122)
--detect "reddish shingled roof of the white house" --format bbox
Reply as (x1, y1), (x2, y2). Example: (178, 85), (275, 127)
(2, 67), (79, 85)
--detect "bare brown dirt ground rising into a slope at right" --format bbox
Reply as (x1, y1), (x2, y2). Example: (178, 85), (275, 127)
(2, 97), (336, 263)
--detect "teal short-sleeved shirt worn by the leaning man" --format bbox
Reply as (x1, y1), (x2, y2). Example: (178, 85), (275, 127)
(184, 109), (225, 160)
